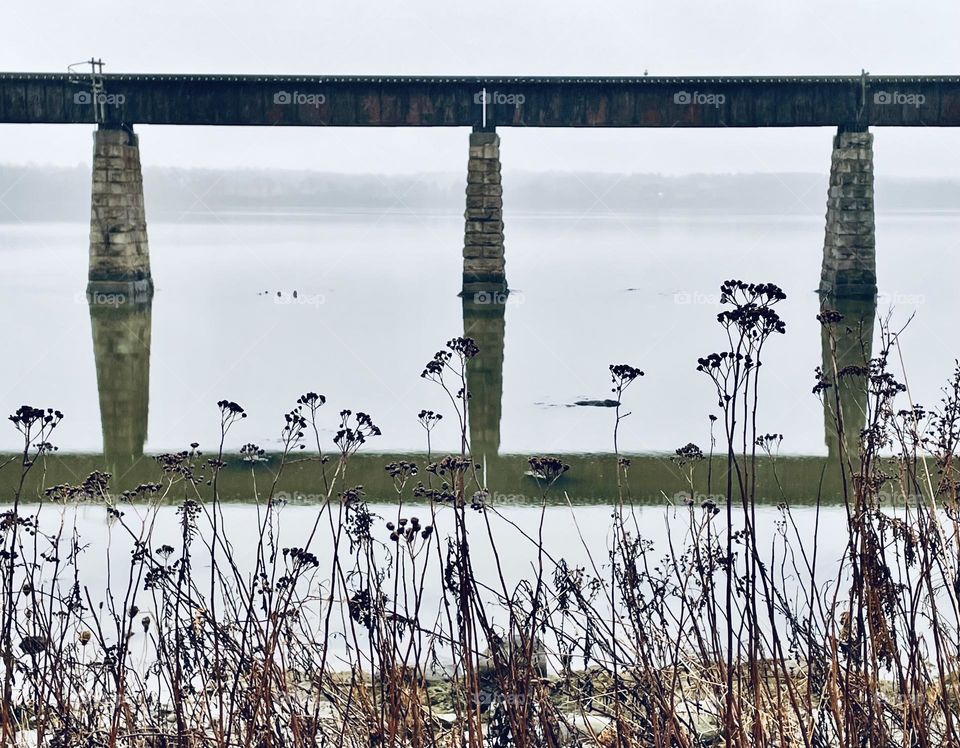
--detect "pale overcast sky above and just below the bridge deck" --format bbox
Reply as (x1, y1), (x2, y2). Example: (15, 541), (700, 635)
(0, 0), (960, 178)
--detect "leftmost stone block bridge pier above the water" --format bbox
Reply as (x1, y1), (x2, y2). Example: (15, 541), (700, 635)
(87, 125), (153, 302)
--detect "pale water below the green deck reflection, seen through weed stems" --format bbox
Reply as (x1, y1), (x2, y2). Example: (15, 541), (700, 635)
(16, 503), (847, 671)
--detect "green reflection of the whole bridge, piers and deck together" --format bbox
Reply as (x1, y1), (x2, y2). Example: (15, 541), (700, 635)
(0, 290), (876, 504)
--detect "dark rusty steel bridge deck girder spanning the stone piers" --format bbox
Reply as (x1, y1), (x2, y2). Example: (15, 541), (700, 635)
(0, 73), (960, 128)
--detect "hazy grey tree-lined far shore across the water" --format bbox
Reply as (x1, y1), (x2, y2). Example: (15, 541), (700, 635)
(0, 165), (960, 223)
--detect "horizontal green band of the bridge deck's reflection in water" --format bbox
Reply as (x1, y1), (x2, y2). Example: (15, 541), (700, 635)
(0, 452), (864, 505)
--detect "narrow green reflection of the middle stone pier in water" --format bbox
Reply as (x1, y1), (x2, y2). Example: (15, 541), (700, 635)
(463, 293), (506, 460)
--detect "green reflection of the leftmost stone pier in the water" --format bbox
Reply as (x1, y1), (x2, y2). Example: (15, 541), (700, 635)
(89, 294), (151, 465)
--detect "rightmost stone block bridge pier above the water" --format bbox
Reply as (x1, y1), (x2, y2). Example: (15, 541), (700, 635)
(820, 127), (877, 297)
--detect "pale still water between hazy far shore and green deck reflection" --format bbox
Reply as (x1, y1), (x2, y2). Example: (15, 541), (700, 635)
(0, 207), (960, 455)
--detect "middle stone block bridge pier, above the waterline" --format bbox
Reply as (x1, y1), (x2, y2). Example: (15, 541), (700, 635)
(463, 131), (507, 297)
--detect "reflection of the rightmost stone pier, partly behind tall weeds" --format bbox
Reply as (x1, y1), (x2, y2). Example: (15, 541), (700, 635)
(820, 295), (877, 465)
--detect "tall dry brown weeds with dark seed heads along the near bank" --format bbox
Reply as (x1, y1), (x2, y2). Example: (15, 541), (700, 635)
(0, 281), (960, 748)
